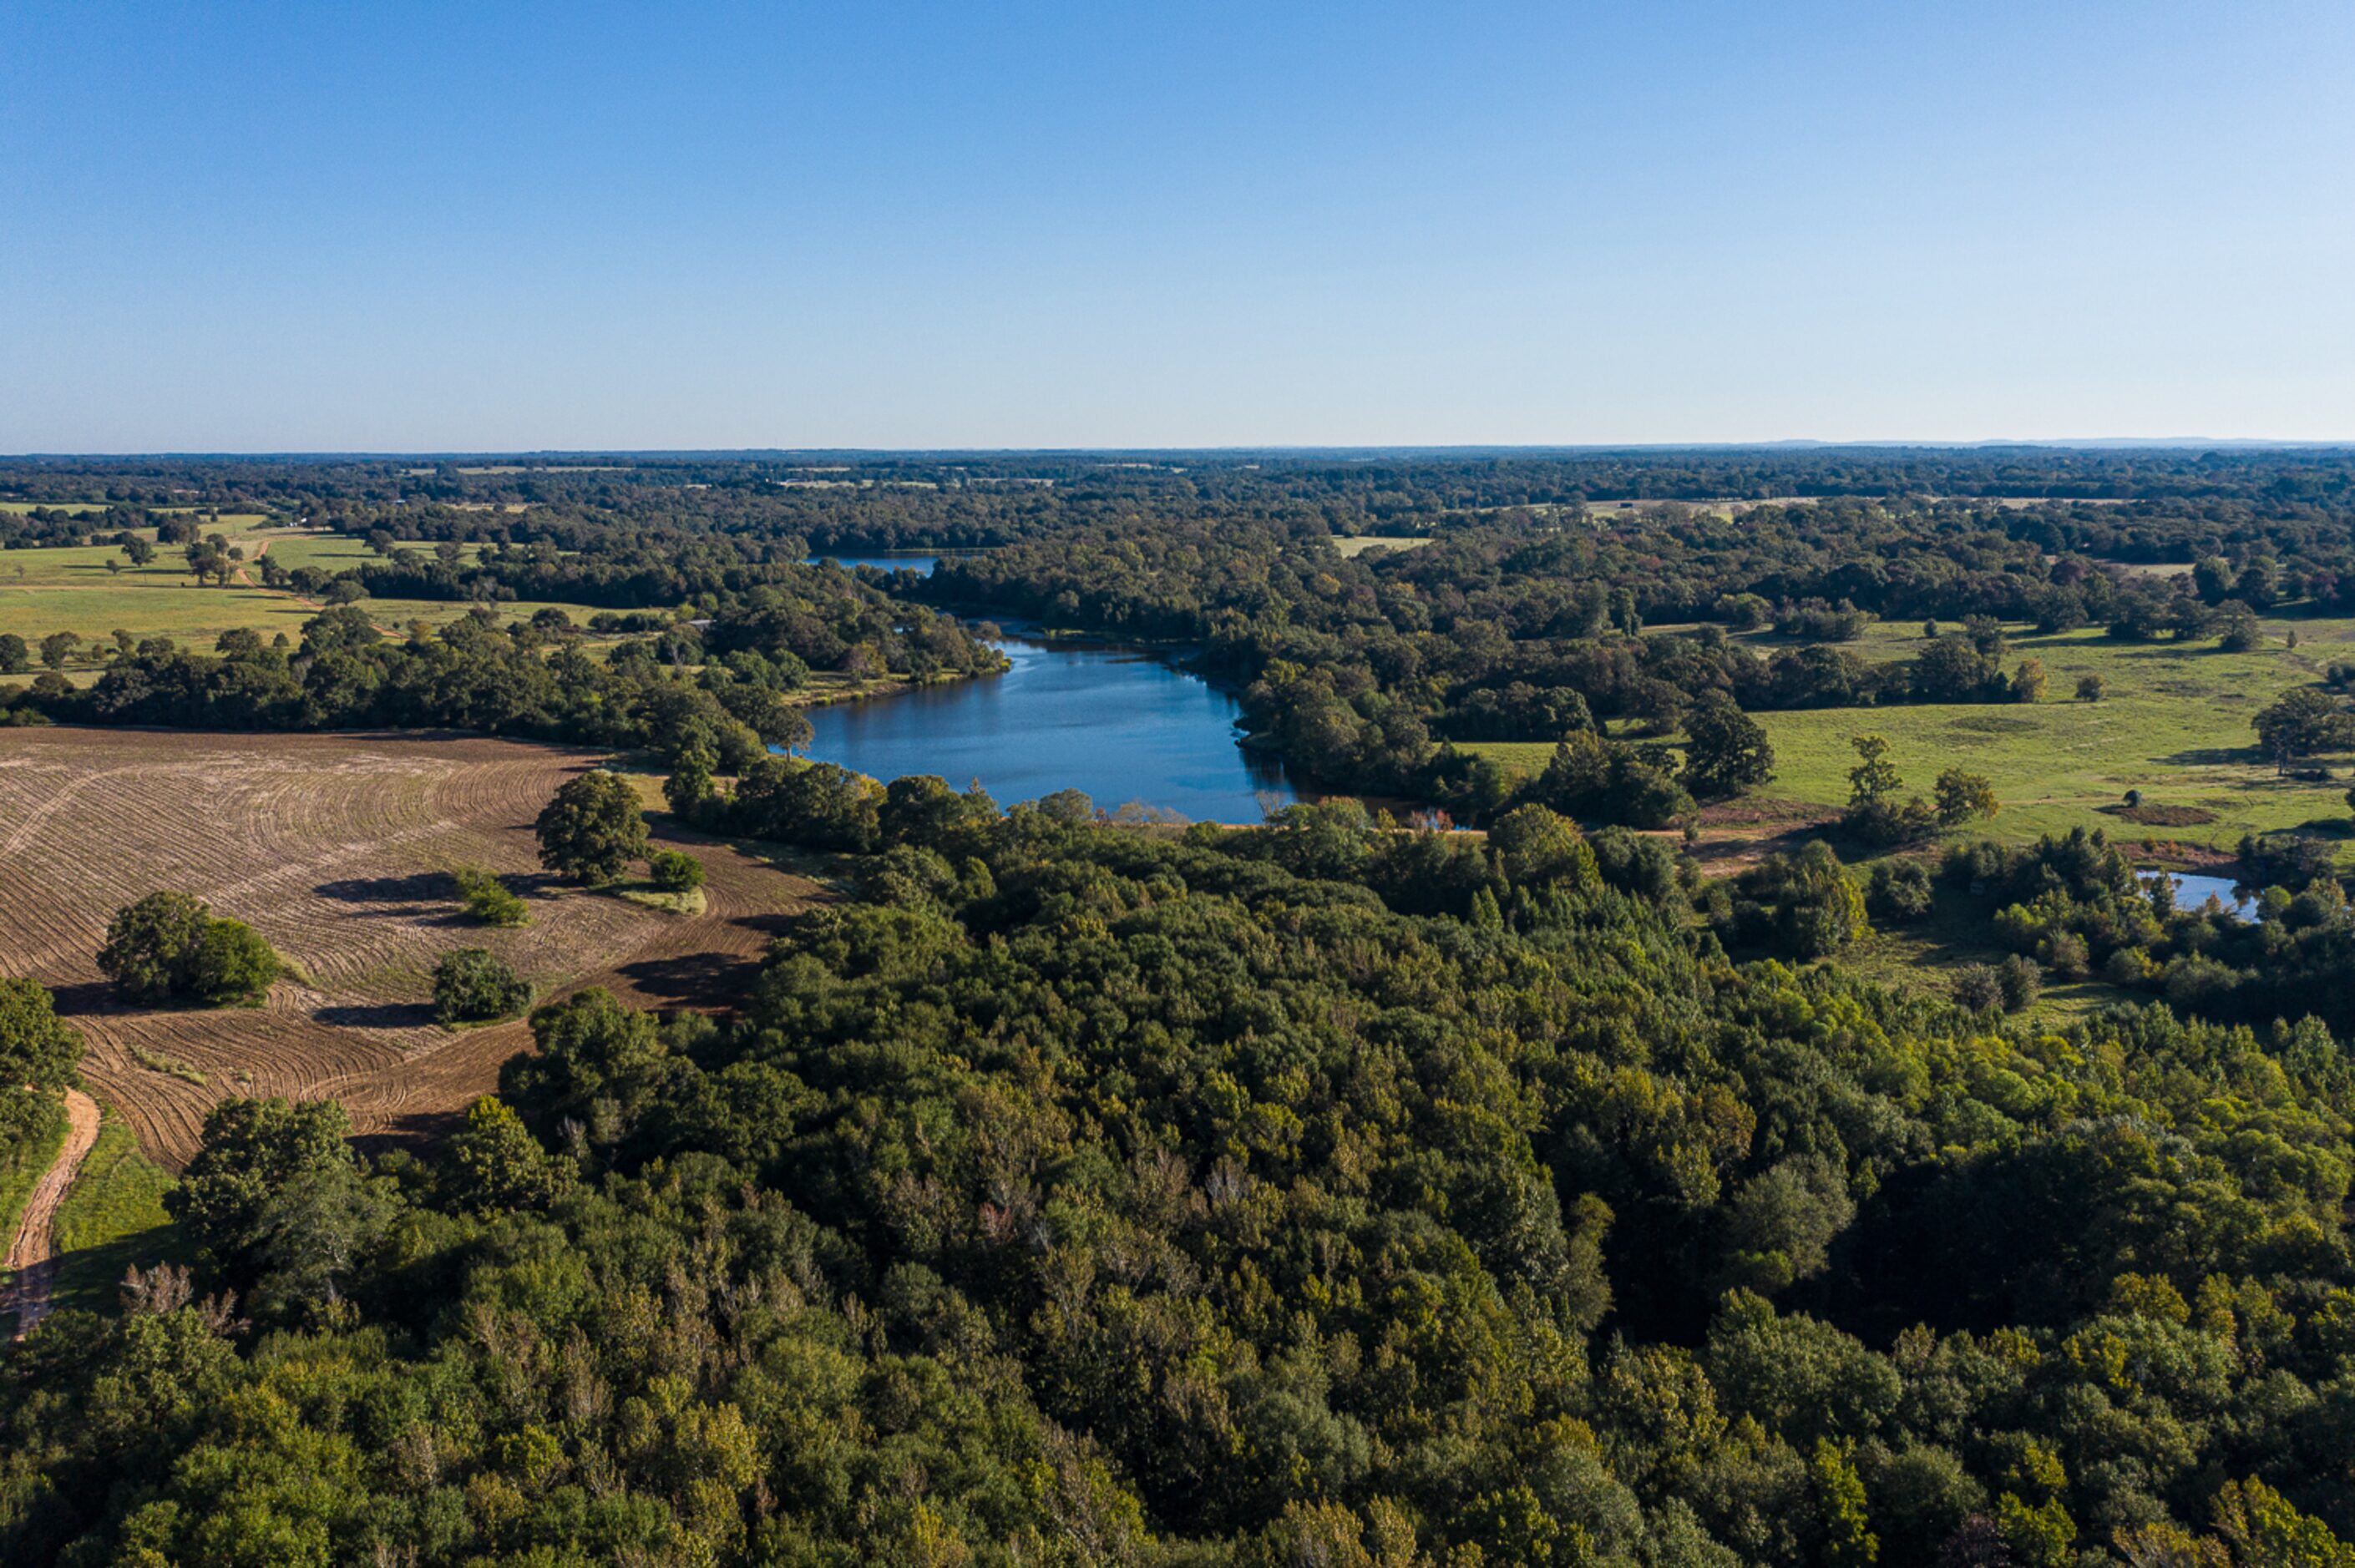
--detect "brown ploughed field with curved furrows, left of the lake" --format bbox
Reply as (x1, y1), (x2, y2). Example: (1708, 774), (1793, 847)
(0, 727), (818, 1166)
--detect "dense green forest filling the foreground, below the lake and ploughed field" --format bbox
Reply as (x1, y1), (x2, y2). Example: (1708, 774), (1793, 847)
(0, 781), (2355, 1568)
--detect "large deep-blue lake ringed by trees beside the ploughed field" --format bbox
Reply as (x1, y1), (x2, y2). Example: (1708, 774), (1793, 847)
(805, 635), (1298, 822)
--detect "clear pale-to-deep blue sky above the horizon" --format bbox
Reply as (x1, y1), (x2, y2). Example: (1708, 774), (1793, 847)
(0, 0), (2355, 452)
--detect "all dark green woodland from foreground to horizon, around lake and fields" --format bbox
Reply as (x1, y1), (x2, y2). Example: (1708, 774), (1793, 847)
(0, 448), (2355, 1568)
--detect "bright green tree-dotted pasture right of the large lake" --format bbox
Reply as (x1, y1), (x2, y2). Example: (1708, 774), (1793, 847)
(1472, 620), (2355, 847)
